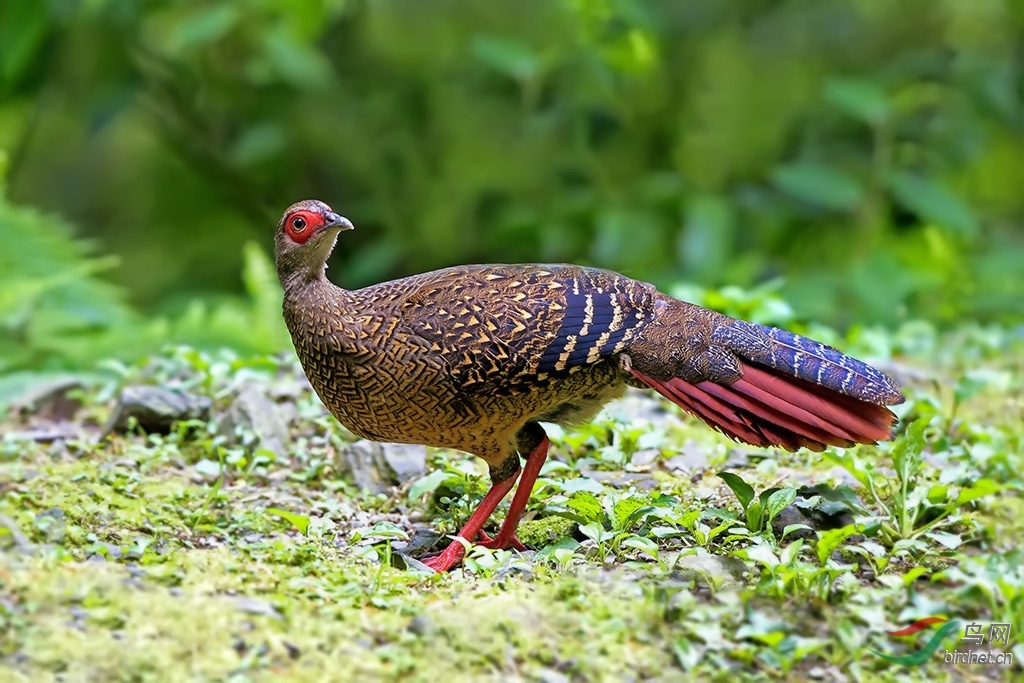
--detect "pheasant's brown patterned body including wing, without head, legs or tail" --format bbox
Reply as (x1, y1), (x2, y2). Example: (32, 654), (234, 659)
(285, 265), (656, 467)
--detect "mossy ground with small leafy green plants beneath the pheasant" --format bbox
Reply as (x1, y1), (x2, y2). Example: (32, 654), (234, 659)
(0, 325), (1024, 683)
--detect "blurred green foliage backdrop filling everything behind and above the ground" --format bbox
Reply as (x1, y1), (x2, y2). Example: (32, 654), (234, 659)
(0, 0), (1024, 372)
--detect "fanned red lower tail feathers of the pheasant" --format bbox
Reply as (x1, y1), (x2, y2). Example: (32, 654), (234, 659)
(632, 365), (896, 451)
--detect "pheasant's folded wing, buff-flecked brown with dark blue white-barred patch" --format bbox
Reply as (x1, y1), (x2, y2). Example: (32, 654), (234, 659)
(396, 265), (656, 394)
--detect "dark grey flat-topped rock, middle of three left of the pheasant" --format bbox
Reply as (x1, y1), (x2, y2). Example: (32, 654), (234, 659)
(100, 386), (213, 438)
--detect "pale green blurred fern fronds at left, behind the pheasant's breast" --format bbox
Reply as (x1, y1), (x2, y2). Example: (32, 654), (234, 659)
(0, 184), (289, 378)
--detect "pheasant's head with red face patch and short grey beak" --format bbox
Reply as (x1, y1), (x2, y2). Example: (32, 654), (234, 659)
(274, 200), (352, 287)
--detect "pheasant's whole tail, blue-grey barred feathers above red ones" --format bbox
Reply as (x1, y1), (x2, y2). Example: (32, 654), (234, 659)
(632, 321), (903, 451)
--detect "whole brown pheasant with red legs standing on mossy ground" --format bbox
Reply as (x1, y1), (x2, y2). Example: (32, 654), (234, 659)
(274, 200), (903, 572)
